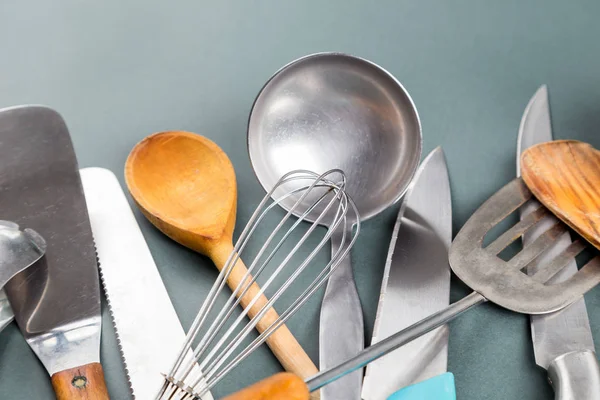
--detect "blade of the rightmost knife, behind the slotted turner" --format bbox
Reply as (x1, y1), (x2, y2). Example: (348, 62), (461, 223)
(517, 85), (594, 369)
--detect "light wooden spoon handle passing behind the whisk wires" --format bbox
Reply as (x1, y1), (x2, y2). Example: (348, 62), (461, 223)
(211, 244), (319, 399)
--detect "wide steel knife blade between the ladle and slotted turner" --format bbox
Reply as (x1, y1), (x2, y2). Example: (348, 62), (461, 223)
(362, 148), (452, 400)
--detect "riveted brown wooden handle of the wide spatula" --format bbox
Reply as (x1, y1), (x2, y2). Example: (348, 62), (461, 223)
(52, 363), (110, 400)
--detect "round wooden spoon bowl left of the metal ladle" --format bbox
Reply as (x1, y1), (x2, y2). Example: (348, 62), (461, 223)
(125, 132), (237, 258)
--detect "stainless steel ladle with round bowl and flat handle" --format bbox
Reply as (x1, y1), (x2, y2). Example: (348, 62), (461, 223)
(248, 53), (422, 400)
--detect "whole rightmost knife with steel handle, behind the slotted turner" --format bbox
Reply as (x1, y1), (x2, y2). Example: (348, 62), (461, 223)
(517, 85), (600, 400)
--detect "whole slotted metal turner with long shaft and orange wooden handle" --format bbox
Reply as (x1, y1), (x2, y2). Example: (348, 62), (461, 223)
(227, 178), (600, 400)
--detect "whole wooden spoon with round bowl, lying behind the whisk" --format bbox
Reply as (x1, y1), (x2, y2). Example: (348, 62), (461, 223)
(125, 131), (318, 388)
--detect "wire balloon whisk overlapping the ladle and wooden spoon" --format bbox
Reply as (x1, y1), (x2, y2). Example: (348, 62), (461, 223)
(156, 170), (360, 399)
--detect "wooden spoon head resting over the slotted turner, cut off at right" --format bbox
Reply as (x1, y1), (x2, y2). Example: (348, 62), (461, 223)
(521, 140), (600, 249)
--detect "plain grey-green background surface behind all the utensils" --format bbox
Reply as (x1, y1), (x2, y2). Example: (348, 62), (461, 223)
(0, 0), (600, 400)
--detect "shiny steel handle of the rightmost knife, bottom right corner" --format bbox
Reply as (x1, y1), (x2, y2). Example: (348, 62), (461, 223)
(548, 351), (600, 400)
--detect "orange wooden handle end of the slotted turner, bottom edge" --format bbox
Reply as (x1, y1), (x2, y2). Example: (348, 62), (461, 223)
(223, 372), (309, 400)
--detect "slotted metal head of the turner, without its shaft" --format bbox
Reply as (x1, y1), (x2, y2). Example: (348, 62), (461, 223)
(449, 178), (600, 314)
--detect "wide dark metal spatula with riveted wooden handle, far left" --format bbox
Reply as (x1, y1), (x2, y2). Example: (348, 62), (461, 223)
(0, 106), (108, 400)
